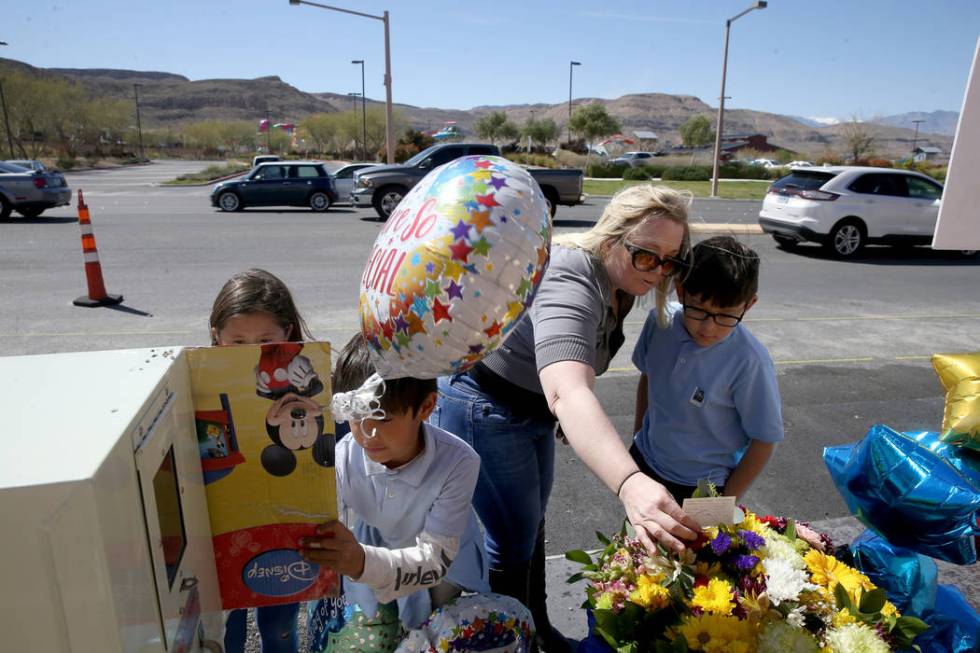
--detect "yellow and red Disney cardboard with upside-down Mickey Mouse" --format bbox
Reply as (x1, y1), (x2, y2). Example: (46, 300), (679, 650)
(188, 342), (340, 610)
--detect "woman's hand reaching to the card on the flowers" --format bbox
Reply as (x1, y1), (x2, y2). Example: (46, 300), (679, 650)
(619, 473), (701, 553)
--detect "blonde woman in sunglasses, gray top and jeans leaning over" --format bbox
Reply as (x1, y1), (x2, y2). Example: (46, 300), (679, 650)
(432, 184), (698, 653)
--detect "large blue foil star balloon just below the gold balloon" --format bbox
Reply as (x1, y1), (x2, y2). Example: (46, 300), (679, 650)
(823, 424), (980, 565)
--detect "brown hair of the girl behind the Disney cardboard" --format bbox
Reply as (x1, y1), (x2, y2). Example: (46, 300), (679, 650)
(208, 268), (311, 345)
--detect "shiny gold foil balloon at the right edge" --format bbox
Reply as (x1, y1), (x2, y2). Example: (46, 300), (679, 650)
(932, 352), (980, 451)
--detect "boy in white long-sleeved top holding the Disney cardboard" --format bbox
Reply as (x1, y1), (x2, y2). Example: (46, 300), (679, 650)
(301, 334), (489, 648)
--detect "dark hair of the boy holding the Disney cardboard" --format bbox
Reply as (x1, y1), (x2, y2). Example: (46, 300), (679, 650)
(333, 333), (437, 417)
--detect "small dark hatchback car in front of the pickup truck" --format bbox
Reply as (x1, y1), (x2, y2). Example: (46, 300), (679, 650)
(211, 161), (337, 212)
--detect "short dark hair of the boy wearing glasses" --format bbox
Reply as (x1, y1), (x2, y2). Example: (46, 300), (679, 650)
(681, 236), (759, 306)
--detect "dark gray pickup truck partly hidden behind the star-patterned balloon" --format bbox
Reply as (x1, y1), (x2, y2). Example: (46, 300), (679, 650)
(350, 143), (585, 220)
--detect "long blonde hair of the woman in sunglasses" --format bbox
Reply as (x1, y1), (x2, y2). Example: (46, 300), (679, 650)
(555, 184), (692, 327)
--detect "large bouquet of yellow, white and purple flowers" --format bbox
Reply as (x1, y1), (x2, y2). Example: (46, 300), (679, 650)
(566, 512), (927, 653)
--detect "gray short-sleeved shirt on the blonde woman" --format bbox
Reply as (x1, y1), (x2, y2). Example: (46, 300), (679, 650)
(483, 246), (633, 394)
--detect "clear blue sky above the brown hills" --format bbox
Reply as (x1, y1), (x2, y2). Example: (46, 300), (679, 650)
(0, 0), (980, 119)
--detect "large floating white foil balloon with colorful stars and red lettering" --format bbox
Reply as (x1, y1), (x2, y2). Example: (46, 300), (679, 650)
(360, 156), (551, 379)
